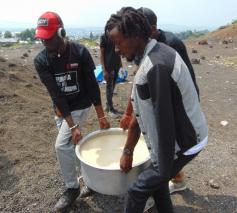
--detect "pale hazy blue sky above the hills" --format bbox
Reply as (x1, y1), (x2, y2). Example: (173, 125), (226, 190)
(0, 0), (237, 28)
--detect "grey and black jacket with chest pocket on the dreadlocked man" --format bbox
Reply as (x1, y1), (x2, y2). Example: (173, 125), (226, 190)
(131, 39), (208, 178)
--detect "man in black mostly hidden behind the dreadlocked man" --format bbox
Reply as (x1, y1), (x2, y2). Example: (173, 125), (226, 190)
(120, 7), (199, 196)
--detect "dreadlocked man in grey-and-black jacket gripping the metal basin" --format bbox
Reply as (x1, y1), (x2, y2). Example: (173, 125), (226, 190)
(107, 8), (208, 213)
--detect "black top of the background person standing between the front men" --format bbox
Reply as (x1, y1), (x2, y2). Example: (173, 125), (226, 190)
(100, 34), (121, 72)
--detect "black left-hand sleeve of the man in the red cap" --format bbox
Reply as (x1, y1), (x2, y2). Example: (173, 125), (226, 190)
(34, 57), (70, 117)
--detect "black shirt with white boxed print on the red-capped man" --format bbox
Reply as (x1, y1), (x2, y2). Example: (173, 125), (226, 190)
(34, 42), (101, 117)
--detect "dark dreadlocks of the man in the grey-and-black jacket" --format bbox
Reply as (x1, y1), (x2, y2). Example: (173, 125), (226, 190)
(105, 7), (151, 40)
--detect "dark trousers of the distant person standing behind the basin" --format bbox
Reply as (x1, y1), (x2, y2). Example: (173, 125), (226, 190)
(106, 70), (118, 110)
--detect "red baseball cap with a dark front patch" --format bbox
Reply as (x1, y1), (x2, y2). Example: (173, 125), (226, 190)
(35, 12), (63, 39)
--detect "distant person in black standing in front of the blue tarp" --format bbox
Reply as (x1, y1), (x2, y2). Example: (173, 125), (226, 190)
(100, 29), (122, 117)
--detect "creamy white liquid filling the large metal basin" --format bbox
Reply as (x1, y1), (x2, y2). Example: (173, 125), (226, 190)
(80, 134), (149, 169)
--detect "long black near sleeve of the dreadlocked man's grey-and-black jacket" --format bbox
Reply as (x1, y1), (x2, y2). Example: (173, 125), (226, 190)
(147, 65), (175, 181)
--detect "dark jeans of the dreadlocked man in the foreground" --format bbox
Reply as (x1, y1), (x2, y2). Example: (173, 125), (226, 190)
(124, 154), (198, 213)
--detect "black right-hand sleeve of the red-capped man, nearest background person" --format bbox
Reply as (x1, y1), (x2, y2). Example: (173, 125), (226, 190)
(81, 48), (101, 106)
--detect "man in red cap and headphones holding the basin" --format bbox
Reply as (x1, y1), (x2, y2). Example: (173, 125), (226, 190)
(34, 12), (110, 211)
